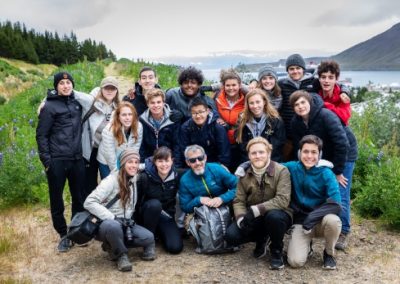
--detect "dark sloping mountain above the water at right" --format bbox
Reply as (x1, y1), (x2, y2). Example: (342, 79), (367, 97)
(332, 23), (400, 71)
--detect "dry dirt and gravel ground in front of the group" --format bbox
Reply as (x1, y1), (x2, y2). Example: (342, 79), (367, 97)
(0, 208), (400, 283)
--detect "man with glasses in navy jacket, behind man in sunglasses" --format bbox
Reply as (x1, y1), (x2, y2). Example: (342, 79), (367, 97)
(175, 97), (230, 168)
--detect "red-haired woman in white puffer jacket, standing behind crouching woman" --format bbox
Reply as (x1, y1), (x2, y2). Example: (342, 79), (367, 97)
(97, 102), (143, 179)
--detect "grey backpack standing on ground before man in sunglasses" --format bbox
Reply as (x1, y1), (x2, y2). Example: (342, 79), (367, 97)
(188, 205), (237, 254)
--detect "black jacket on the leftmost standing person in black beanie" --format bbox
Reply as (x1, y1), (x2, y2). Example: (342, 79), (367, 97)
(36, 90), (82, 168)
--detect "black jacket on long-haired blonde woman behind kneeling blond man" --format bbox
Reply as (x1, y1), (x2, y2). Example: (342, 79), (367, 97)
(239, 118), (286, 163)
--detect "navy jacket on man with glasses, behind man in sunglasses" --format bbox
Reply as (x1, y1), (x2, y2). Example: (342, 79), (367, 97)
(175, 113), (231, 168)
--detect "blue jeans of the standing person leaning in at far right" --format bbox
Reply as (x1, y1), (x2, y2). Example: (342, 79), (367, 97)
(339, 161), (355, 234)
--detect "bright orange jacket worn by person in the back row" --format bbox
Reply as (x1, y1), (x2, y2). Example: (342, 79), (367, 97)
(215, 90), (244, 144)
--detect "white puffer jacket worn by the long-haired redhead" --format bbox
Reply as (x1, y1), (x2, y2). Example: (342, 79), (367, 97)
(97, 122), (143, 171)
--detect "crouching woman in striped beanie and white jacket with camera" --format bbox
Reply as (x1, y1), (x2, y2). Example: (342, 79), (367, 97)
(84, 149), (156, 271)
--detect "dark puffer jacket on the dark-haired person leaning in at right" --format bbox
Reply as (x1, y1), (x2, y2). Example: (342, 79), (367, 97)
(291, 95), (349, 175)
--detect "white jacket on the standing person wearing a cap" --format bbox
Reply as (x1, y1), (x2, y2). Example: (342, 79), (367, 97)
(75, 87), (117, 161)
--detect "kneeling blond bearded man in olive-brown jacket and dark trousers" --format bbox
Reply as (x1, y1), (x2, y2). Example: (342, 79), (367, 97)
(226, 137), (292, 269)
